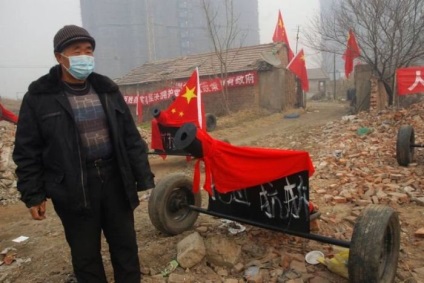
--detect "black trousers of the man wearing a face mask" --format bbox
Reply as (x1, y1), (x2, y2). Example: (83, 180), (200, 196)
(55, 162), (141, 283)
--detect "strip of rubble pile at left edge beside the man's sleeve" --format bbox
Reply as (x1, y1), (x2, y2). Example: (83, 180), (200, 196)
(0, 121), (20, 205)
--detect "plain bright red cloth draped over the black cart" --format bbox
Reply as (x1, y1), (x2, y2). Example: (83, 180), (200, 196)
(193, 129), (315, 194)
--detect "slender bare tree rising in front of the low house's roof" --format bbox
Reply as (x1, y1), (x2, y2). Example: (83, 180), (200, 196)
(202, 0), (246, 113)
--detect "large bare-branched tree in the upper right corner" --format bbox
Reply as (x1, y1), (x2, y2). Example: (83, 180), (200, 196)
(307, 0), (424, 102)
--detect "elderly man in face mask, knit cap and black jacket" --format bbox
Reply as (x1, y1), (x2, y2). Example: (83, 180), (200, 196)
(13, 25), (154, 283)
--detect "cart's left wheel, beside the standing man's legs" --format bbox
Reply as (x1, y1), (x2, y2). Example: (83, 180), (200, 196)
(149, 173), (202, 235)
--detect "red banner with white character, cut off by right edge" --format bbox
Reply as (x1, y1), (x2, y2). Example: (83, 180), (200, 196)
(396, 66), (424, 95)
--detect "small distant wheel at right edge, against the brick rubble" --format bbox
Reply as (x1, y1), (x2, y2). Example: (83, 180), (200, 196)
(396, 125), (415, 166)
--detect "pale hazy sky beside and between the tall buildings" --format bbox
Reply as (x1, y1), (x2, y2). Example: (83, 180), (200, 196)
(0, 0), (319, 98)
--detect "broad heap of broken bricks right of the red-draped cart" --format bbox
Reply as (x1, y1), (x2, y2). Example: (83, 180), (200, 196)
(311, 103), (424, 209)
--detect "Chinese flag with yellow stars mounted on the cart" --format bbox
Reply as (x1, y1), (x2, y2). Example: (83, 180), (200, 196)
(151, 68), (206, 150)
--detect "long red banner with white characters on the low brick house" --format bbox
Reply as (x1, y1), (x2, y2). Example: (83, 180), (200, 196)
(124, 71), (258, 105)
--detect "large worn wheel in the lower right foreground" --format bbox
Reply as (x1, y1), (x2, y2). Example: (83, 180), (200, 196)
(348, 205), (400, 283)
